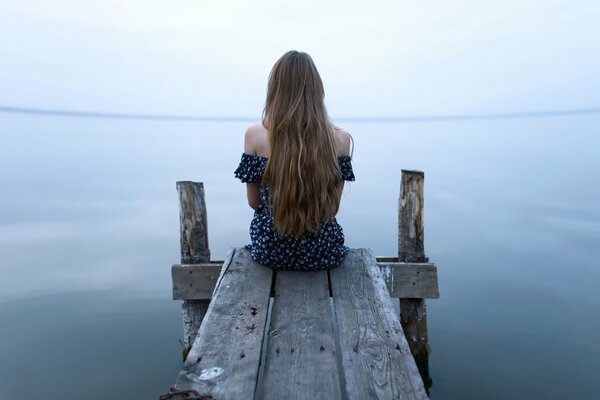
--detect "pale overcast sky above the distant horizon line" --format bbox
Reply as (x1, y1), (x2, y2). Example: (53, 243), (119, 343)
(0, 0), (600, 118)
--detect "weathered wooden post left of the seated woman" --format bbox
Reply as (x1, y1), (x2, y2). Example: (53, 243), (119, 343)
(177, 181), (210, 359)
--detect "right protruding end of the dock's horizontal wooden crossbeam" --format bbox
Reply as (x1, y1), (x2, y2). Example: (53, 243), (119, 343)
(377, 261), (440, 299)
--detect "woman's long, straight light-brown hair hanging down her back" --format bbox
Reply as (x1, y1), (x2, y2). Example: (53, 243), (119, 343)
(263, 51), (341, 237)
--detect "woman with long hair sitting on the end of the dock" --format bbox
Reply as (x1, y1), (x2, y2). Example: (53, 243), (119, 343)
(235, 51), (354, 271)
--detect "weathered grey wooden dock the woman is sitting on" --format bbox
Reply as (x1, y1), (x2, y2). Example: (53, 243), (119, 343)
(161, 171), (439, 400)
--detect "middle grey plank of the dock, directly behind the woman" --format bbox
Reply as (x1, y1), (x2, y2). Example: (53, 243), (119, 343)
(261, 271), (341, 400)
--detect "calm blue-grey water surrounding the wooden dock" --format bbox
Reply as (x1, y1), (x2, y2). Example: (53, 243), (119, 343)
(0, 115), (600, 399)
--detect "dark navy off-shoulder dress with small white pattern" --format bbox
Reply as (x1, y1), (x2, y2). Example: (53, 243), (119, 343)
(235, 153), (354, 271)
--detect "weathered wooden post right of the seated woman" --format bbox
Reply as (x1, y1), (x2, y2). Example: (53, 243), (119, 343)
(398, 170), (431, 387)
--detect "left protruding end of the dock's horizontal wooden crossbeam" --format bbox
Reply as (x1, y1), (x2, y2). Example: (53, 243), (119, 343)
(171, 262), (223, 300)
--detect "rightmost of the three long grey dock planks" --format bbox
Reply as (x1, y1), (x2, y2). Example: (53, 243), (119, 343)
(329, 249), (427, 400)
